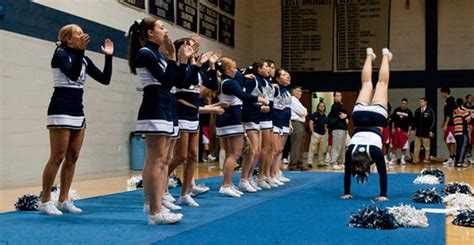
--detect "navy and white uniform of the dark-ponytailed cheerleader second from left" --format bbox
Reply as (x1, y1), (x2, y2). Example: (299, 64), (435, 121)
(135, 42), (182, 136)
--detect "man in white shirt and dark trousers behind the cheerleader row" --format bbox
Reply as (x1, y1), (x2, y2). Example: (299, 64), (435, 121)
(288, 87), (308, 170)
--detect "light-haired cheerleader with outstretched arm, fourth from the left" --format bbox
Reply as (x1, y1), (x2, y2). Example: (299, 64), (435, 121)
(216, 58), (269, 197)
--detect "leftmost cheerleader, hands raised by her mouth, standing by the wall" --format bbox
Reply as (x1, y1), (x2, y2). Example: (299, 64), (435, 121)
(38, 24), (114, 215)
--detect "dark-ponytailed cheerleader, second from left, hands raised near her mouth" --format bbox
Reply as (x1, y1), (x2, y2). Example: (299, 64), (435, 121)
(128, 17), (194, 224)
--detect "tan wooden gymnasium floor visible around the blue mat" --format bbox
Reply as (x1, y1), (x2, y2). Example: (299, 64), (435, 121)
(0, 162), (474, 244)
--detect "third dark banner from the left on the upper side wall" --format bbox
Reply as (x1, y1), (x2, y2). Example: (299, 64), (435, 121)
(176, 0), (198, 33)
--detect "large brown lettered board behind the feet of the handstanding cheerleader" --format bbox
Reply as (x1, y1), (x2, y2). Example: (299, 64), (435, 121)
(335, 0), (390, 71)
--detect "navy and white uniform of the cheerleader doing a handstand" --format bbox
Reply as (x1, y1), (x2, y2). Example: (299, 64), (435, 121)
(344, 103), (388, 196)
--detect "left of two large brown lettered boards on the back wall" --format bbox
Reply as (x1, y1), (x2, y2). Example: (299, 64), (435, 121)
(282, 0), (334, 71)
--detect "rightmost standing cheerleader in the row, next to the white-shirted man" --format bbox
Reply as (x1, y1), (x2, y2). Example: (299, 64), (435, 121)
(271, 69), (291, 183)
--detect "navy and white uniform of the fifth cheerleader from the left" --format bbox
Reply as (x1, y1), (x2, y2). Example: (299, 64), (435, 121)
(242, 75), (265, 131)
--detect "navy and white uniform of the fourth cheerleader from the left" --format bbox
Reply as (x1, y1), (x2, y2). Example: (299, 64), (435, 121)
(216, 72), (258, 137)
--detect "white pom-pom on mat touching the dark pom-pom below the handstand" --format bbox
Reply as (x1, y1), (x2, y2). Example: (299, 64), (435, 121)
(388, 204), (428, 228)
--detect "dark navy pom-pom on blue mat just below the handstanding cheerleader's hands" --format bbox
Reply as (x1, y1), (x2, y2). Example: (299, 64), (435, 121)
(349, 205), (398, 230)
